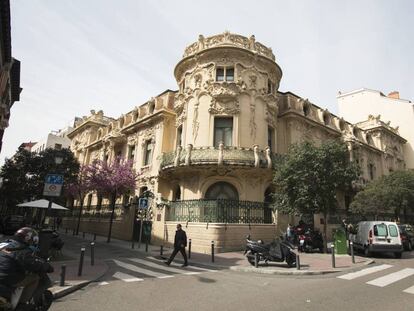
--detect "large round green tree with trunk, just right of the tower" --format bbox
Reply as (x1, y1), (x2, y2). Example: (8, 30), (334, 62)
(273, 140), (359, 251)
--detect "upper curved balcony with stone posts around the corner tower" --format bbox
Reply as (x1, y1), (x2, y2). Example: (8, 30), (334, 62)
(160, 145), (279, 170)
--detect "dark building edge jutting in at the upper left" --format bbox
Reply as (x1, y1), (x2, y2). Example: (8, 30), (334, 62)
(0, 0), (22, 152)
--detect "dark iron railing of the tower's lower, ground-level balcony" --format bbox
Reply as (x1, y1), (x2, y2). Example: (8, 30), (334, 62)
(166, 199), (272, 224)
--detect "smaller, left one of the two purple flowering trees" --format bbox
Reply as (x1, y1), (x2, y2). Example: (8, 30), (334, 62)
(66, 165), (92, 235)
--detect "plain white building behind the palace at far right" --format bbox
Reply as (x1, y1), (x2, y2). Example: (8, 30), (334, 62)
(337, 88), (414, 170)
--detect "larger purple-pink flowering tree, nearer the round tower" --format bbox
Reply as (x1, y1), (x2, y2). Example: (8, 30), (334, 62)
(88, 158), (137, 243)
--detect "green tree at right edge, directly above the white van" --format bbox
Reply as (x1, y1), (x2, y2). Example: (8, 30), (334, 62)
(350, 170), (414, 221)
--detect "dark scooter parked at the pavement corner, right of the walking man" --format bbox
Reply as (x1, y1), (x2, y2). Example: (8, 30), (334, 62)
(244, 235), (296, 267)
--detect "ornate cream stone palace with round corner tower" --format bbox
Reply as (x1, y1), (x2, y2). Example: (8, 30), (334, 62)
(64, 32), (406, 252)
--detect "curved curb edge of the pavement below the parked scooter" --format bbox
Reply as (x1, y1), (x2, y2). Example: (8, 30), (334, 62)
(230, 259), (375, 275)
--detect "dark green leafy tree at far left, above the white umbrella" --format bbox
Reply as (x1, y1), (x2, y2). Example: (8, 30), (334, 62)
(0, 148), (79, 211)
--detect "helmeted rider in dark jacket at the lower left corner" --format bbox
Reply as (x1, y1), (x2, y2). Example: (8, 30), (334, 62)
(0, 227), (53, 310)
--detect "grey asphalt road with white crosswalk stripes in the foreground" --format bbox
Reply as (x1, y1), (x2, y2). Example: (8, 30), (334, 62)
(51, 253), (414, 311)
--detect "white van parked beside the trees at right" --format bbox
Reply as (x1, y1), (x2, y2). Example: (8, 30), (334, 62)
(349, 221), (403, 258)
